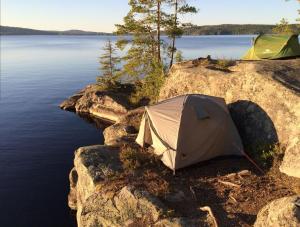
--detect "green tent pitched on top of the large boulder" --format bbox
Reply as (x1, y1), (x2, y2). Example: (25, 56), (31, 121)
(242, 35), (300, 60)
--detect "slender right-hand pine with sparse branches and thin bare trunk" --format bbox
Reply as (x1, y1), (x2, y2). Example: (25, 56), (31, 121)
(166, 0), (198, 67)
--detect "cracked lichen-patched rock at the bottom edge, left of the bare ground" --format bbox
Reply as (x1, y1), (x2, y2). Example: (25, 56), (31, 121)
(78, 186), (165, 227)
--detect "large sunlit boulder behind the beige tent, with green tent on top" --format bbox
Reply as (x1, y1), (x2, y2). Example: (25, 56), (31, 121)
(160, 59), (300, 177)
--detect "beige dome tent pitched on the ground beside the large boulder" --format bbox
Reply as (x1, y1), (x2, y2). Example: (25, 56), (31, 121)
(136, 95), (243, 170)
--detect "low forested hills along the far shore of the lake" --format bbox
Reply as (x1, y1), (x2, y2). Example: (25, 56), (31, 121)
(0, 24), (297, 36)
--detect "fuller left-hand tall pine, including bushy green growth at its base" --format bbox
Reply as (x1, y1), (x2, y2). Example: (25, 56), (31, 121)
(116, 0), (167, 102)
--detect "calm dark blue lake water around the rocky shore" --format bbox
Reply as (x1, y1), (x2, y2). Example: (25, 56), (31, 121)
(0, 36), (252, 227)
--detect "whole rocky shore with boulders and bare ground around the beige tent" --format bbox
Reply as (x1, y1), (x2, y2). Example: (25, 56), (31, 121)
(60, 60), (300, 226)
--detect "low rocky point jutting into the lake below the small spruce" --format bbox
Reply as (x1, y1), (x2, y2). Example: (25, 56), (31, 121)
(60, 85), (130, 122)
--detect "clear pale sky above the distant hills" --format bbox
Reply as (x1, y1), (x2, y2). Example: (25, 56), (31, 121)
(0, 0), (300, 32)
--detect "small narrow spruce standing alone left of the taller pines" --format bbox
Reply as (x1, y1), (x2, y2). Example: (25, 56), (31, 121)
(97, 40), (121, 88)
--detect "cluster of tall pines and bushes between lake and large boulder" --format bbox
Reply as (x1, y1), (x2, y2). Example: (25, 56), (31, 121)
(116, 0), (197, 104)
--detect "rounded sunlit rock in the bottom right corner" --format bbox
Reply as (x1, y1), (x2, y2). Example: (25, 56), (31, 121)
(254, 196), (300, 227)
